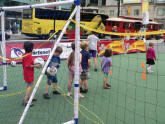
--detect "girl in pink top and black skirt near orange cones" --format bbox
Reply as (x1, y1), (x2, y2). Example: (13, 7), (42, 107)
(146, 42), (156, 73)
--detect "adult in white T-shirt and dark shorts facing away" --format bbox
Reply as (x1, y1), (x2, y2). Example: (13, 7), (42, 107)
(87, 32), (100, 71)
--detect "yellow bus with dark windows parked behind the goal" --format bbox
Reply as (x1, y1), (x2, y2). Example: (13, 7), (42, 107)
(22, 8), (108, 38)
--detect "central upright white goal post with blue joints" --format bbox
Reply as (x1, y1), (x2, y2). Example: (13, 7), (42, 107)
(74, 0), (80, 124)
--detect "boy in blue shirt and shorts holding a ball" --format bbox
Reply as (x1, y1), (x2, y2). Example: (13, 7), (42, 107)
(43, 46), (63, 99)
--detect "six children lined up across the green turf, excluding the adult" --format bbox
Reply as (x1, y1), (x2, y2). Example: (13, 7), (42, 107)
(22, 41), (156, 106)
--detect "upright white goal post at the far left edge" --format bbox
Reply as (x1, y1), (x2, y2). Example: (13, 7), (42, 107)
(1, 9), (7, 90)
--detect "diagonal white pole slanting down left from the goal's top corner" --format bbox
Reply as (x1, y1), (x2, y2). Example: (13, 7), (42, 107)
(18, 7), (77, 124)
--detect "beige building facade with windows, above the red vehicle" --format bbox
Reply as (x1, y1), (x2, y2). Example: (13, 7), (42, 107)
(84, 0), (165, 25)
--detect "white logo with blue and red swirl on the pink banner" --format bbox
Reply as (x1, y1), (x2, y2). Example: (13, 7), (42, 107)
(11, 48), (25, 59)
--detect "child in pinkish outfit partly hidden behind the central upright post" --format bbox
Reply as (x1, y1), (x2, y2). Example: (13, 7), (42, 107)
(67, 43), (84, 97)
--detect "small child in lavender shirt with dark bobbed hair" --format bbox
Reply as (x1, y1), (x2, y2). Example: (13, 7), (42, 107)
(101, 48), (112, 89)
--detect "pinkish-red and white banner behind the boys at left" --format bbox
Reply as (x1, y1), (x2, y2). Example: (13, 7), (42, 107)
(6, 41), (72, 63)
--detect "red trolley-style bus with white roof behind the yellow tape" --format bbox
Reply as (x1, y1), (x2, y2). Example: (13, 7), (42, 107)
(105, 16), (164, 39)
